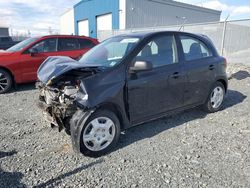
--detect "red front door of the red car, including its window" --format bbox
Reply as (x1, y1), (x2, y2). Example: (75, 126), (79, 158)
(20, 38), (57, 82)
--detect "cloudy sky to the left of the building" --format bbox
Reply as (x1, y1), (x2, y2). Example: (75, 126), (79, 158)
(0, 0), (79, 35)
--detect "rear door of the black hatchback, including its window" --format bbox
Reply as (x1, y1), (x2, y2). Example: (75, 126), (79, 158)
(179, 34), (216, 105)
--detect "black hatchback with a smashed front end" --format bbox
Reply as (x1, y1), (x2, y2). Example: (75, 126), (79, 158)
(38, 31), (228, 156)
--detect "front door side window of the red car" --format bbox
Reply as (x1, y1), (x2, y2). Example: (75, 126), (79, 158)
(31, 38), (57, 53)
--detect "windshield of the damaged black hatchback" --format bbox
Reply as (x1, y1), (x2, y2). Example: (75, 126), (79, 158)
(79, 37), (139, 67)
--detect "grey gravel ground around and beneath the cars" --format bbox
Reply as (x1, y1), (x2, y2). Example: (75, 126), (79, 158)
(0, 65), (250, 187)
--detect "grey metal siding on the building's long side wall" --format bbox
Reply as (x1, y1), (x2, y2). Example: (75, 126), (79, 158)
(126, 0), (221, 29)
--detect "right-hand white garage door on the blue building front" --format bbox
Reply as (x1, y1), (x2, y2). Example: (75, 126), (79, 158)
(96, 14), (112, 36)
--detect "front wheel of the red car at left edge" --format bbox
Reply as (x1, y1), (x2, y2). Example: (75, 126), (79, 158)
(0, 69), (13, 94)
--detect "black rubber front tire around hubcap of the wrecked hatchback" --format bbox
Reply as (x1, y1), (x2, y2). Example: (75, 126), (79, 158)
(80, 109), (121, 157)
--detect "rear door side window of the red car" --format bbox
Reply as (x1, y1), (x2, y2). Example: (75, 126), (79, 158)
(58, 38), (80, 51)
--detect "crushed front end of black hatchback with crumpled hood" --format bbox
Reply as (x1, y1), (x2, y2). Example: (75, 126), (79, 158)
(36, 57), (98, 133)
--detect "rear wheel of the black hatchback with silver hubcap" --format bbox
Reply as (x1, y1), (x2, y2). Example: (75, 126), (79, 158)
(203, 82), (225, 113)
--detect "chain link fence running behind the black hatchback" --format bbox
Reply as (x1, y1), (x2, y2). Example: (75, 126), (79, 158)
(98, 19), (250, 65)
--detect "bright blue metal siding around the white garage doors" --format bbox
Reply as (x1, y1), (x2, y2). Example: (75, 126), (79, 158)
(74, 0), (119, 38)
